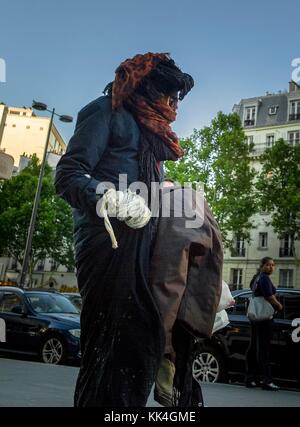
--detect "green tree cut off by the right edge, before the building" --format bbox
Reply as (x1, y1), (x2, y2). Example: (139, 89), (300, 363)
(256, 139), (300, 257)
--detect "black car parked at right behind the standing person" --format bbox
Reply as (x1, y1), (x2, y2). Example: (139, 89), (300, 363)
(193, 288), (300, 385)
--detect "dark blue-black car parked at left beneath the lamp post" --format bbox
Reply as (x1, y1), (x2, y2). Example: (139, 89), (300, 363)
(0, 287), (80, 364)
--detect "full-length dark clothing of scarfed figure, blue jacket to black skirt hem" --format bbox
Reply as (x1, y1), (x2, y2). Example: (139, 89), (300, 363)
(55, 97), (164, 407)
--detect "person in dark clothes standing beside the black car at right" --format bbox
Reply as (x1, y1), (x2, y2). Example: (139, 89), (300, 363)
(245, 257), (282, 390)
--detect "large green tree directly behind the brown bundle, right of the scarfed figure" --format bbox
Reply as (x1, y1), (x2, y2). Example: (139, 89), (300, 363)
(166, 112), (256, 247)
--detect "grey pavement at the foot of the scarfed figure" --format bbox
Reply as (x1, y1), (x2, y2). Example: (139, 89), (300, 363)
(0, 358), (300, 407)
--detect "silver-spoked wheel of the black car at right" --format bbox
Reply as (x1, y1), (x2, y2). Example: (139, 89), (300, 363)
(192, 346), (227, 383)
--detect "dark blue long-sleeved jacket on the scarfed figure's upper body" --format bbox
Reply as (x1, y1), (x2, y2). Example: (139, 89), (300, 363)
(55, 96), (140, 259)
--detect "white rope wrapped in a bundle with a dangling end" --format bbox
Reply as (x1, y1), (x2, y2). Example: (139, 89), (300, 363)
(99, 188), (151, 249)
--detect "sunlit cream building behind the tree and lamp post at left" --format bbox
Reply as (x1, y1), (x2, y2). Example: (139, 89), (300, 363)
(0, 104), (77, 289)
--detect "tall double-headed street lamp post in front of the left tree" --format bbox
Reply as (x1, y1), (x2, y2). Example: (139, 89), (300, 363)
(19, 101), (73, 287)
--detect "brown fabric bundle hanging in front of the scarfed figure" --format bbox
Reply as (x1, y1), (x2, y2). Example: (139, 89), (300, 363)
(151, 188), (223, 353)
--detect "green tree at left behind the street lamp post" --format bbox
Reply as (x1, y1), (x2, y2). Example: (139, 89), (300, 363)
(0, 155), (74, 283)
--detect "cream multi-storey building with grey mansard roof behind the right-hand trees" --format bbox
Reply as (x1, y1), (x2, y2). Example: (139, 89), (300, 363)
(223, 81), (300, 289)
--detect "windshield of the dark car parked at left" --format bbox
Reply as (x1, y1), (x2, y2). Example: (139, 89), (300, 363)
(26, 292), (79, 314)
